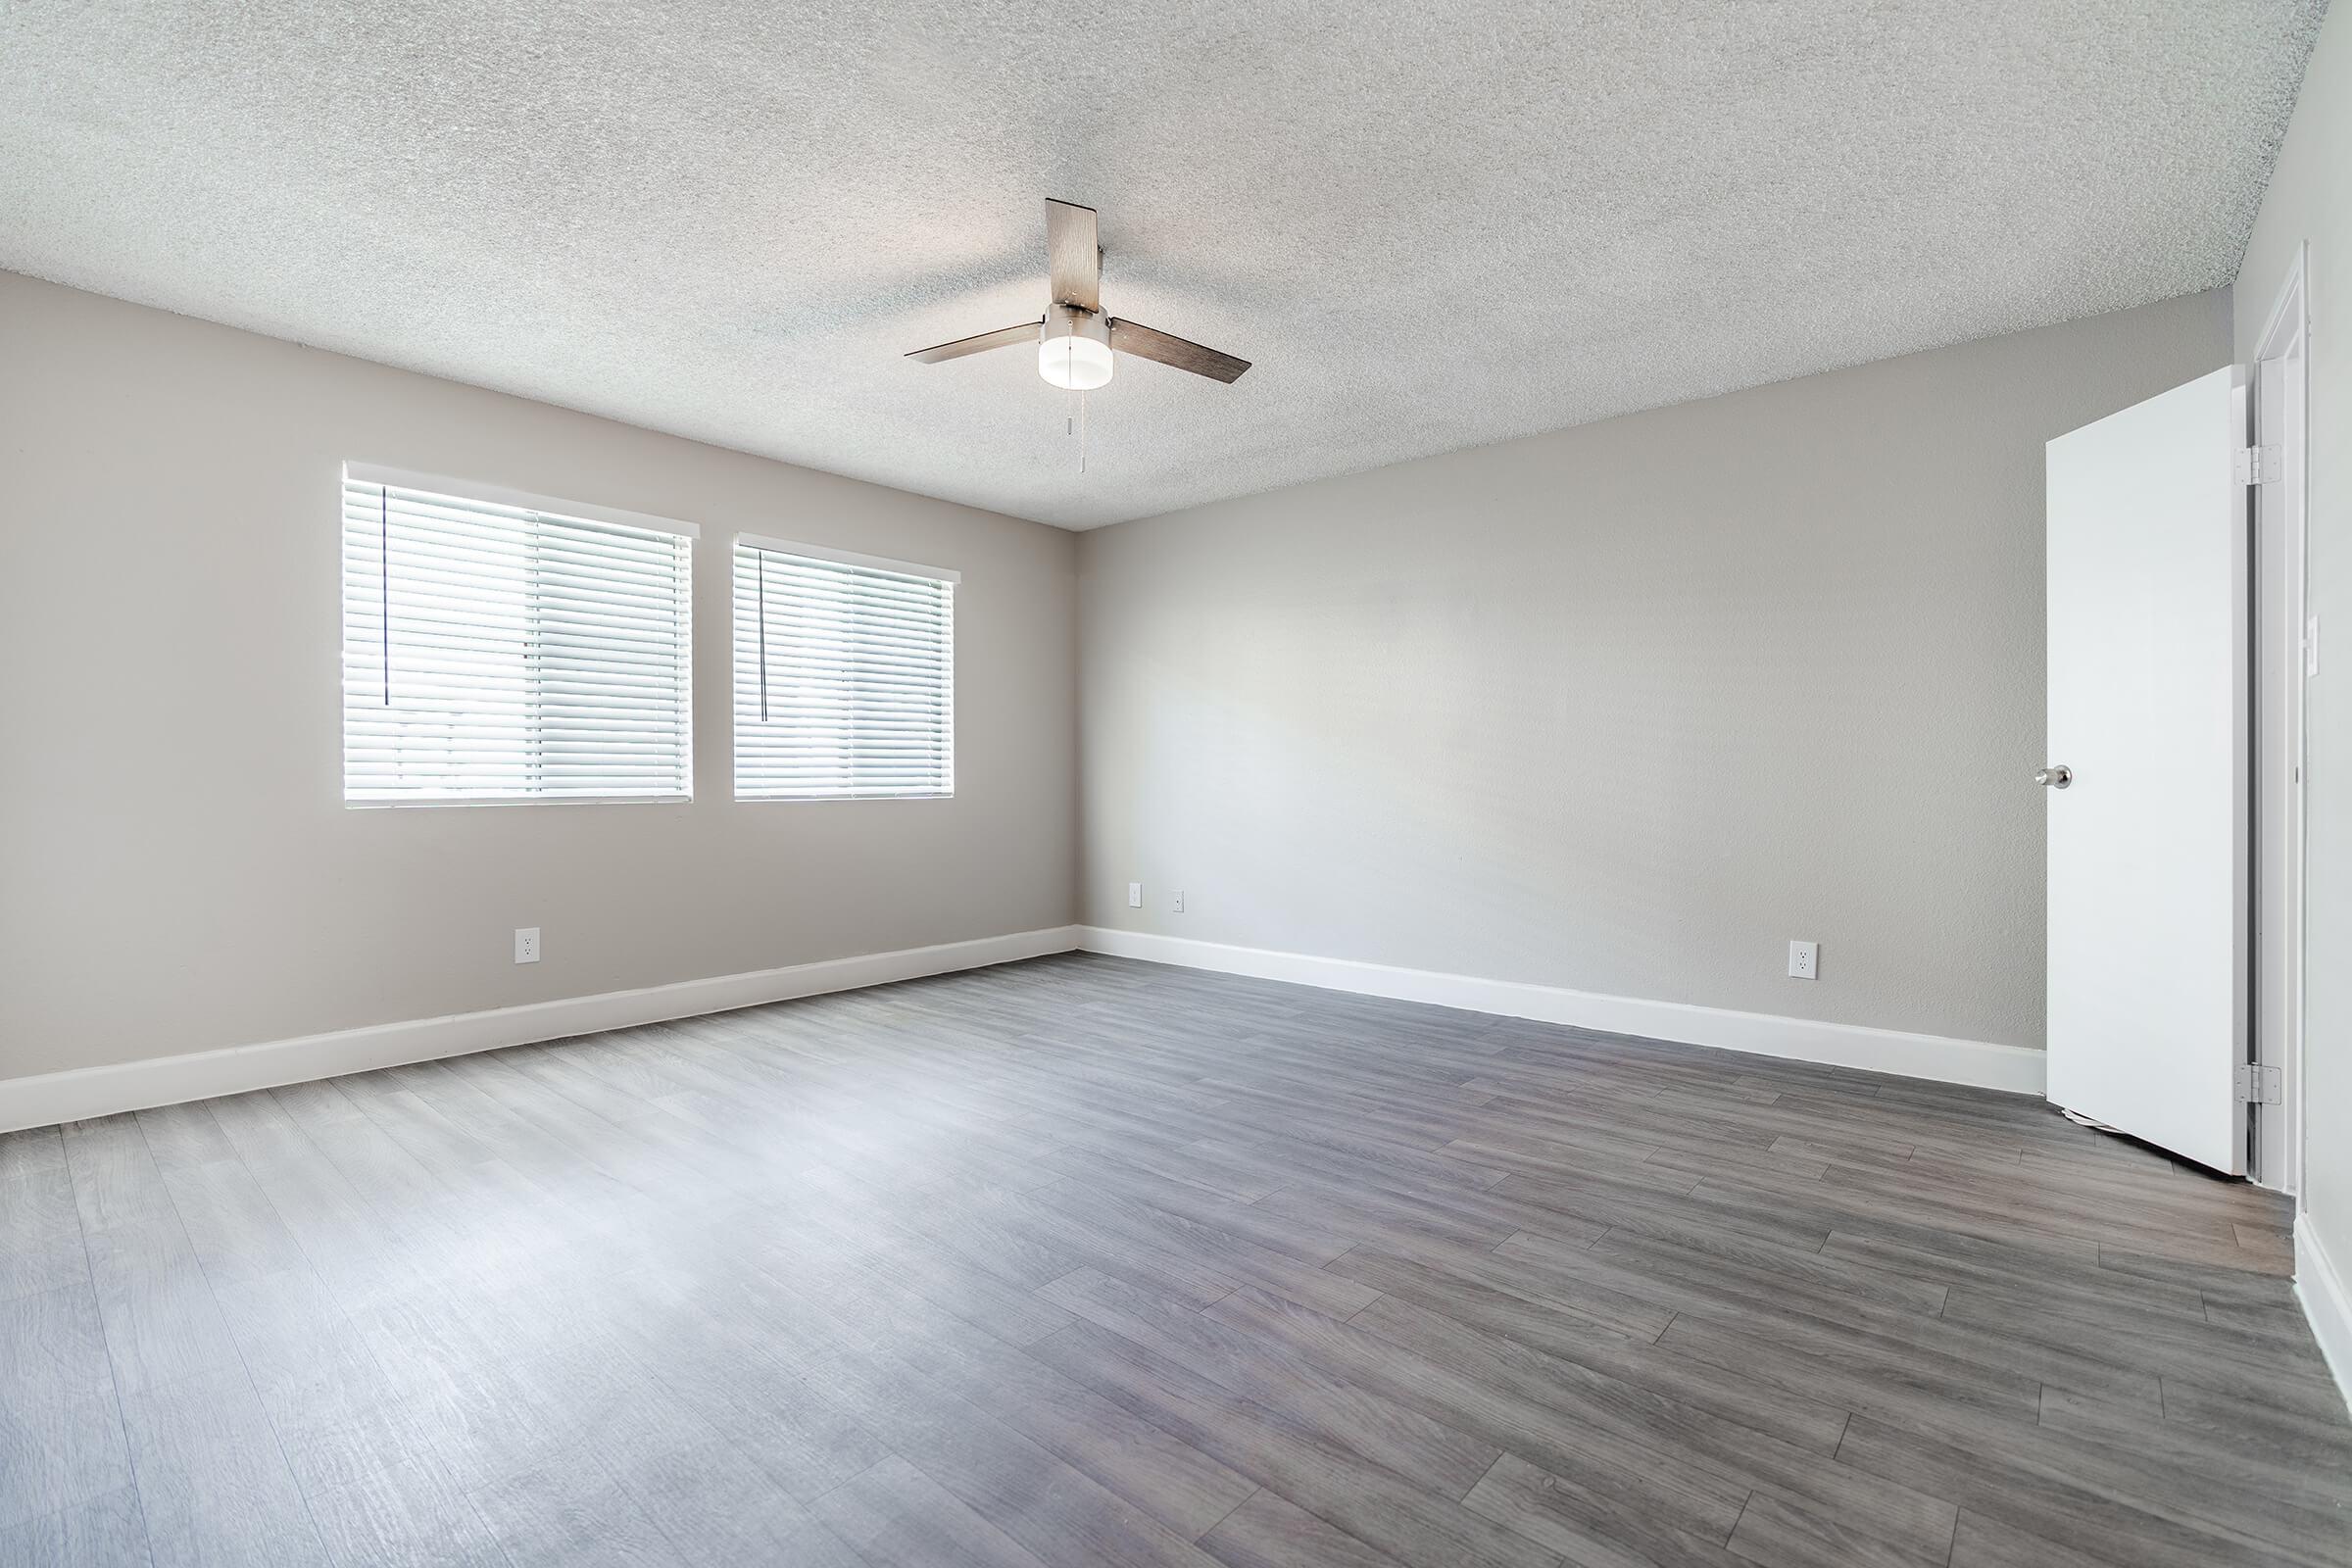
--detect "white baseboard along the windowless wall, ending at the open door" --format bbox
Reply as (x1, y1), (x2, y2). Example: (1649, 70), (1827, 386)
(1082, 926), (2041, 1096)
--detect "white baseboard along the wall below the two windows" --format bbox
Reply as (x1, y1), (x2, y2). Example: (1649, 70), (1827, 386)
(0, 926), (1080, 1133)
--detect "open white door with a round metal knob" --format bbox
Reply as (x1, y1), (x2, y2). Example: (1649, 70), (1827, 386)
(2046, 367), (2251, 1173)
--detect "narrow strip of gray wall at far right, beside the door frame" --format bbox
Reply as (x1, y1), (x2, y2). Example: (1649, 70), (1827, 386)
(2236, 7), (2352, 1272)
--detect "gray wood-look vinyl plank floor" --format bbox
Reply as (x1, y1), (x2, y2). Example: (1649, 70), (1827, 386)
(0, 955), (2352, 1568)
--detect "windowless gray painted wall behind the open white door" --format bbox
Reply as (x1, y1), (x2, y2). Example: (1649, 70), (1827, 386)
(1080, 291), (2230, 1046)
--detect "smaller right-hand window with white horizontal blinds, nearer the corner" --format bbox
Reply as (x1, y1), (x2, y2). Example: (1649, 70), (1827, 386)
(734, 536), (957, 800)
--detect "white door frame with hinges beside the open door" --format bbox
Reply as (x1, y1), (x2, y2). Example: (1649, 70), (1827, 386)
(2248, 244), (2312, 1195)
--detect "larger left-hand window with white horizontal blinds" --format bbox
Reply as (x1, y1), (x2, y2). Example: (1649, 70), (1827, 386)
(343, 466), (694, 804)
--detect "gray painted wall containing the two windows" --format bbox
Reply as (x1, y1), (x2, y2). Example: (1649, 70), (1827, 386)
(0, 275), (1077, 1077)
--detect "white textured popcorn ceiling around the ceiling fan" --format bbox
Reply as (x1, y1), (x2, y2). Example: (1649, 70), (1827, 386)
(0, 0), (2324, 526)
